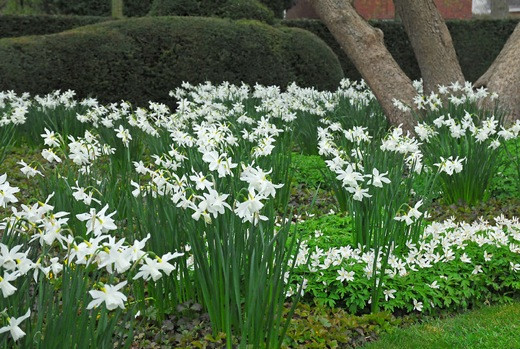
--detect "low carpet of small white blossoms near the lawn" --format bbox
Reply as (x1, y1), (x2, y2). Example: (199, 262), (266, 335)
(288, 212), (520, 311)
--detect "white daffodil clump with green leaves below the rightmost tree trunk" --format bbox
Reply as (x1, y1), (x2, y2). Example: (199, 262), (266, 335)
(394, 82), (520, 205)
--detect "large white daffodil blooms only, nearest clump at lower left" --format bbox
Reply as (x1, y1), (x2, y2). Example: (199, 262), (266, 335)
(0, 174), (184, 341)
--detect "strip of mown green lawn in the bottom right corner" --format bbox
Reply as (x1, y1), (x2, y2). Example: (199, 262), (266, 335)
(364, 302), (520, 349)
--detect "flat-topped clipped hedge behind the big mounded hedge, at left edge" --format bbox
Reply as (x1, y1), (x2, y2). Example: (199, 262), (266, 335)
(0, 15), (111, 38)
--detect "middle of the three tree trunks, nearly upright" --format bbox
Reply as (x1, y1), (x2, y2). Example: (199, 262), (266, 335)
(394, 0), (464, 93)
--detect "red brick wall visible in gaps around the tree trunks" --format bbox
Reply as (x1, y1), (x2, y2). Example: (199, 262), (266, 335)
(287, 0), (472, 19)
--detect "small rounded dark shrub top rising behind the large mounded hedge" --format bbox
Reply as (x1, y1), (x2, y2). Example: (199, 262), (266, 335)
(149, 0), (274, 23)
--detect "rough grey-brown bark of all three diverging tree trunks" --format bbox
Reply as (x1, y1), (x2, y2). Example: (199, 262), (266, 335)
(310, 0), (520, 125)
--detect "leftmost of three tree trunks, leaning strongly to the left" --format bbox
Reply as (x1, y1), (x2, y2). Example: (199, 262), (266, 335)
(310, 0), (417, 132)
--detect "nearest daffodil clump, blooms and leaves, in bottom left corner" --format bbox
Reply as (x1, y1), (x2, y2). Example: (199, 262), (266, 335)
(0, 172), (183, 347)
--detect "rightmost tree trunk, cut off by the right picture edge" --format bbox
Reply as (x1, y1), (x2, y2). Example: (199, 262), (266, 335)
(475, 23), (520, 121)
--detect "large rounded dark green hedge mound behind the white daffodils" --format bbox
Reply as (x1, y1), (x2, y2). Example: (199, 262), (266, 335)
(0, 17), (343, 105)
